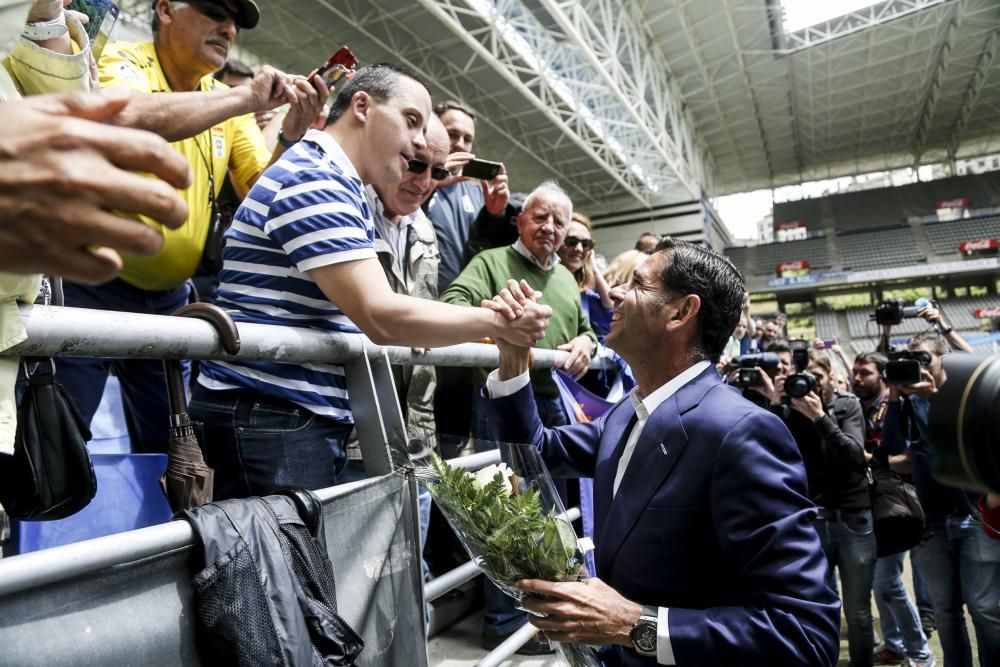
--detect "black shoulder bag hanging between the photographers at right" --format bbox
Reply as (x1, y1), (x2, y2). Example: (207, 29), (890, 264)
(869, 462), (925, 558)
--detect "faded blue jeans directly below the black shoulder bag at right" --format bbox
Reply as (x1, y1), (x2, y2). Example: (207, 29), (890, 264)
(873, 553), (931, 662)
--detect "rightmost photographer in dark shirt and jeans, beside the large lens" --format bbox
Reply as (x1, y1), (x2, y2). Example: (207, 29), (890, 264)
(883, 332), (1000, 666)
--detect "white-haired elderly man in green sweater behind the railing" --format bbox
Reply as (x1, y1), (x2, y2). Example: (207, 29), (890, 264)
(441, 182), (597, 653)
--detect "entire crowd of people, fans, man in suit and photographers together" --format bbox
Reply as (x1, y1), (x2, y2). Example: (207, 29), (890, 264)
(0, 0), (1000, 666)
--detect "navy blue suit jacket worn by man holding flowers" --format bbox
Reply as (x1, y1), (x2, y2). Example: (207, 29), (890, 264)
(487, 367), (840, 667)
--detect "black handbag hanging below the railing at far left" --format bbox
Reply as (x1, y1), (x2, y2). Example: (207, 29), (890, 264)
(0, 359), (97, 521)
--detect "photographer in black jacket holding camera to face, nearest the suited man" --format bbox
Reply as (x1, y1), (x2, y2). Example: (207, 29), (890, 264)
(753, 341), (876, 666)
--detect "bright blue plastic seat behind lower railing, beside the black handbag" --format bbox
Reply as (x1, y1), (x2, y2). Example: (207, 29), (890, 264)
(5, 454), (173, 555)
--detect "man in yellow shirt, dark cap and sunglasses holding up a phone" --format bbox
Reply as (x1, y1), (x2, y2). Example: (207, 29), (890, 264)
(57, 0), (327, 452)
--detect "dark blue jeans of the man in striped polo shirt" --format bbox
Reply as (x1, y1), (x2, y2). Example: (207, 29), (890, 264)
(188, 385), (354, 500)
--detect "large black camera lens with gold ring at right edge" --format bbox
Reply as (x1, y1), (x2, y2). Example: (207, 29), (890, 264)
(930, 354), (1000, 493)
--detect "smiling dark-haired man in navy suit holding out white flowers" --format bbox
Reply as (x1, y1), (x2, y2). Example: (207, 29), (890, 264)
(487, 238), (840, 667)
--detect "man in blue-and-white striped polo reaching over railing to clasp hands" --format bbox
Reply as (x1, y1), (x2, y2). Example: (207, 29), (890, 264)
(189, 64), (551, 499)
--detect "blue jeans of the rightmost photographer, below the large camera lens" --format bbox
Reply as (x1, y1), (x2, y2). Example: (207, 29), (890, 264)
(916, 515), (1000, 667)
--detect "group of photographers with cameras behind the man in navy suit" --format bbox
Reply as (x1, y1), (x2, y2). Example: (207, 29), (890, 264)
(719, 299), (1000, 667)
